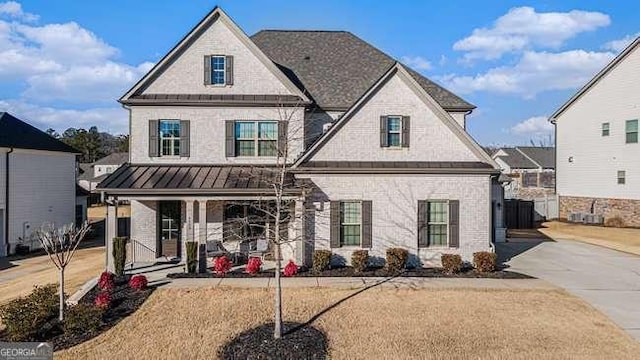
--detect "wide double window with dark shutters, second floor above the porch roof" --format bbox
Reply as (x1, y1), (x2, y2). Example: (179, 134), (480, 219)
(235, 121), (278, 156)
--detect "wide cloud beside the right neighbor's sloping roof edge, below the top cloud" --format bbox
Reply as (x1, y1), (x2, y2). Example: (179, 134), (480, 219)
(438, 50), (614, 98)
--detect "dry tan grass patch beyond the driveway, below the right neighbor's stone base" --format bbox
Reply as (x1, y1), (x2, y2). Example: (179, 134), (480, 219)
(538, 221), (640, 255)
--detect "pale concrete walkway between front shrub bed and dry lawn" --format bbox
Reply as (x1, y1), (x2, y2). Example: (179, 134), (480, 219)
(163, 277), (557, 290)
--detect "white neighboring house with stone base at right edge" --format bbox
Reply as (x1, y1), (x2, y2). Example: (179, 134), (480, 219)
(551, 38), (640, 227)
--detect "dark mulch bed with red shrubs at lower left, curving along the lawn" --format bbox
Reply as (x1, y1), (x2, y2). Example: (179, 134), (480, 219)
(0, 276), (155, 351)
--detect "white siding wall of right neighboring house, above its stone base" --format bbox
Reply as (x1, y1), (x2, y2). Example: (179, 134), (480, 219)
(556, 44), (640, 200)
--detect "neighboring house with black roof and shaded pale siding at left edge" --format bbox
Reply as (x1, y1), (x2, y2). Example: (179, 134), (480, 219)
(0, 113), (77, 256)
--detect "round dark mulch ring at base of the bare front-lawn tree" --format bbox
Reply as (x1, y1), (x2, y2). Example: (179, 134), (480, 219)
(218, 322), (328, 360)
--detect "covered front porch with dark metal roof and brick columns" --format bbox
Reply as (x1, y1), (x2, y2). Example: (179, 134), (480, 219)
(100, 165), (306, 271)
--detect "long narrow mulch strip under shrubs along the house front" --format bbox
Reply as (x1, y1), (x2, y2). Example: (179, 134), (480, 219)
(168, 266), (533, 279)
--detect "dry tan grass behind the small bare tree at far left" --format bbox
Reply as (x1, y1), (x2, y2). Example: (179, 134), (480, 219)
(0, 247), (105, 304)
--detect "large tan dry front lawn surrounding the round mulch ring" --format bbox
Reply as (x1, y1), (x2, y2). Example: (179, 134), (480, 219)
(56, 287), (640, 359)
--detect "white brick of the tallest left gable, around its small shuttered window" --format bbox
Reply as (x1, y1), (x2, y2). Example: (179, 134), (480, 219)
(143, 16), (291, 95)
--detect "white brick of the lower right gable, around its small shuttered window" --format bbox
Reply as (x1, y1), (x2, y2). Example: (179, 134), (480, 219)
(313, 75), (478, 161)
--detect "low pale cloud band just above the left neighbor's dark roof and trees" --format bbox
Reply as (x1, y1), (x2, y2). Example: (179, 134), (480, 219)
(0, 100), (129, 134)
